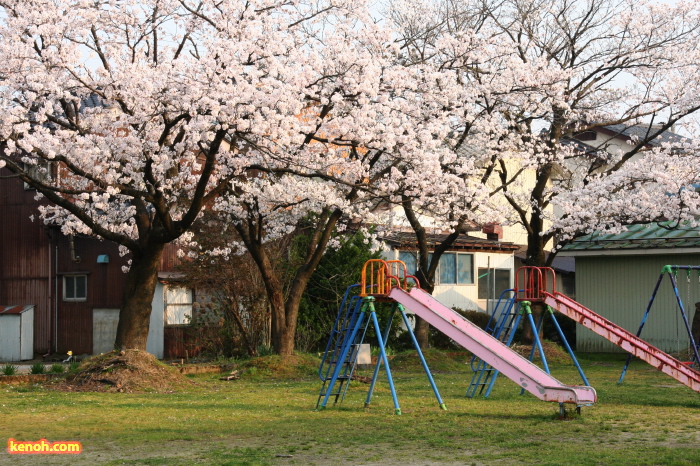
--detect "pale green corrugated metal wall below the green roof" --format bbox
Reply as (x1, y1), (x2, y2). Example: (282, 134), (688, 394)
(576, 254), (700, 352)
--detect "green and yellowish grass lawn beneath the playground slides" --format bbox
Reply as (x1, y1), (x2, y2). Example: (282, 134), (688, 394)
(0, 355), (700, 465)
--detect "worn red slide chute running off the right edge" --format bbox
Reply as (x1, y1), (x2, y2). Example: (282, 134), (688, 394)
(543, 292), (700, 392)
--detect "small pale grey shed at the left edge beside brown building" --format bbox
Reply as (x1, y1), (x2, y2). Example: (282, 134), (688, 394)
(0, 305), (34, 361)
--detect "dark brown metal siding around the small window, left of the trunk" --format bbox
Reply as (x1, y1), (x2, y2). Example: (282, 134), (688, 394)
(0, 170), (131, 354)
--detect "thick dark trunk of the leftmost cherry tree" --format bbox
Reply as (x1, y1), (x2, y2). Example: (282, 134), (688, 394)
(114, 244), (165, 351)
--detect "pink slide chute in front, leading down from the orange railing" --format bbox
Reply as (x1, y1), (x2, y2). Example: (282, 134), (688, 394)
(389, 288), (597, 406)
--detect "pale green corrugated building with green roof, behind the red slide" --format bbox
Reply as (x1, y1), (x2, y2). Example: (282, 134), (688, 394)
(559, 222), (700, 353)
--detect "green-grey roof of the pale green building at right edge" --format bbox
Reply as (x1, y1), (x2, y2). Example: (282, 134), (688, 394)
(563, 222), (700, 252)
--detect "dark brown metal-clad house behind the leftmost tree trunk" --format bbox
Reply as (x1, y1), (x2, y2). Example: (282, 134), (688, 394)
(0, 169), (196, 358)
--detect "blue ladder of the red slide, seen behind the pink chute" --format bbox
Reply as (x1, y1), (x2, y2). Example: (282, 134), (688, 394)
(465, 289), (522, 398)
